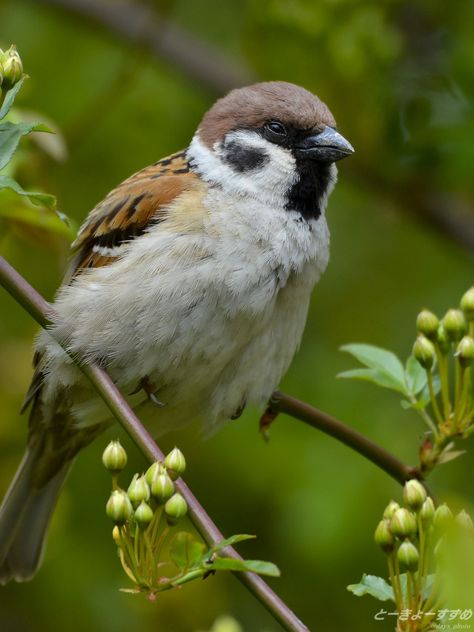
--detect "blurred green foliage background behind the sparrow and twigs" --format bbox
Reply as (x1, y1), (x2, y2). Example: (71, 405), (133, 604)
(0, 0), (474, 632)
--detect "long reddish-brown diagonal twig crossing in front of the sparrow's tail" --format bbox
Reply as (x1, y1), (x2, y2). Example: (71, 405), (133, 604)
(0, 257), (309, 632)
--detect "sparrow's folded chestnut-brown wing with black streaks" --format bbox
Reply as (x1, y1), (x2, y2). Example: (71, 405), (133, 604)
(65, 152), (197, 283)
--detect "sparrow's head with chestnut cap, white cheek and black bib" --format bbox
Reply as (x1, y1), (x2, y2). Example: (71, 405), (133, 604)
(189, 81), (354, 219)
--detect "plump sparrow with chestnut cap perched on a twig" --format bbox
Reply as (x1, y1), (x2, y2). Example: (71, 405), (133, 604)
(0, 81), (354, 583)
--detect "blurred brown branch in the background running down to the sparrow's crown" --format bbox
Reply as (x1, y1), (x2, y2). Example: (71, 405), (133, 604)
(35, 0), (256, 94)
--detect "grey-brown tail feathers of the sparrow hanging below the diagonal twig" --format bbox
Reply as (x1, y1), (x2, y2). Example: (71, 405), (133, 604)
(0, 442), (71, 584)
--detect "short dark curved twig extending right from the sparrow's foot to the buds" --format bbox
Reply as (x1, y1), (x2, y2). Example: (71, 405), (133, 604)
(269, 391), (422, 485)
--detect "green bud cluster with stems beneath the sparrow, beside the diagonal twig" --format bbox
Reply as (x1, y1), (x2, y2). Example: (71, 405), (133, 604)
(102, 441), (188, 590)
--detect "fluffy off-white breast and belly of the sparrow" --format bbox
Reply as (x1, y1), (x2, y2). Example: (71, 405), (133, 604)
(39, 168), (329, 427)
